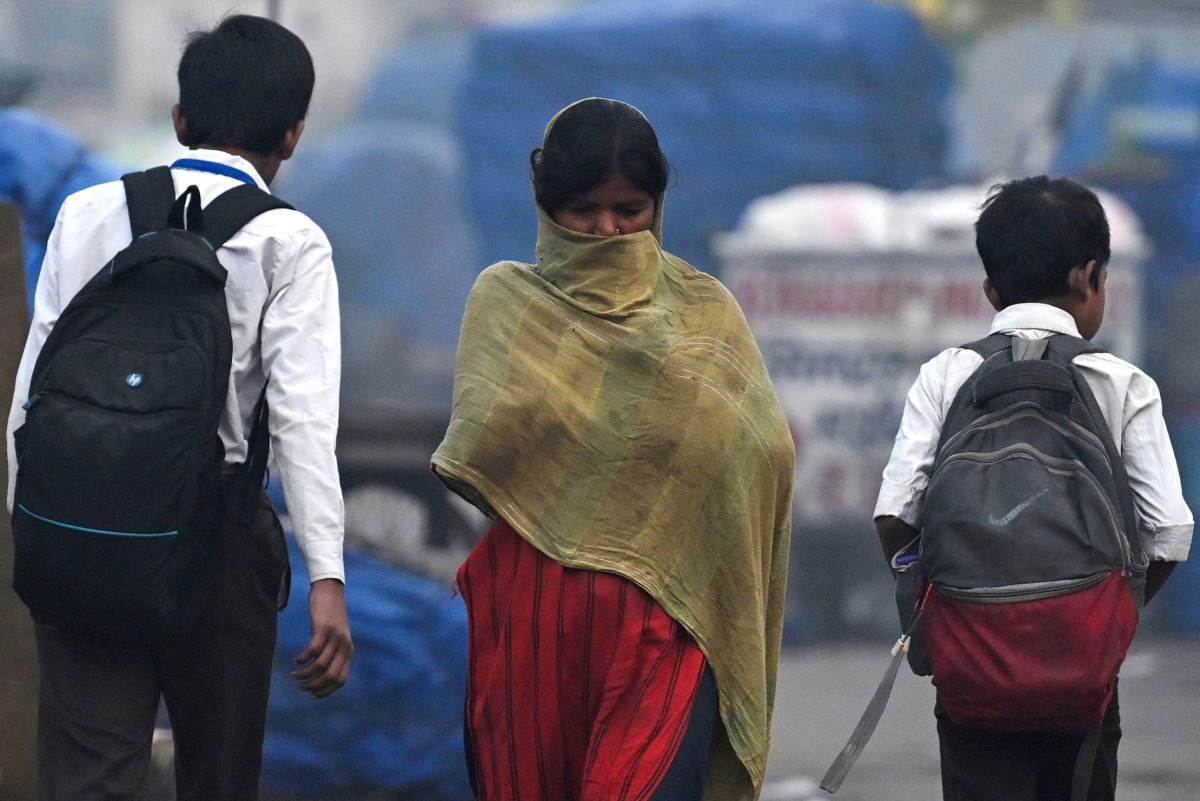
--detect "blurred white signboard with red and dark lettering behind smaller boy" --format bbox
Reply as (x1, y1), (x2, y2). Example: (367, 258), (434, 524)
(720, 251), (1141, 525)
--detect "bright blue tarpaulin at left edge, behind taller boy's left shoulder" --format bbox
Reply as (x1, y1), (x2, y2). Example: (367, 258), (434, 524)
(0, 108), (122, 306)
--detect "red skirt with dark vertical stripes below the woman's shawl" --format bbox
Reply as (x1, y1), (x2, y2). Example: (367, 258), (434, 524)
(458, 520), (704, 801)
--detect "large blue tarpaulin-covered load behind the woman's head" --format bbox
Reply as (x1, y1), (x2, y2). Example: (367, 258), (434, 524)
(458, 0), (953, 270)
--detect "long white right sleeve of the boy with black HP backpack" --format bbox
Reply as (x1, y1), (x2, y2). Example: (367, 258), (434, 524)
(262, 227), (346, 582)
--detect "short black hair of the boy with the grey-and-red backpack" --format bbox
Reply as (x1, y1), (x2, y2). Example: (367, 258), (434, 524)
(976, 175), (1111, 306)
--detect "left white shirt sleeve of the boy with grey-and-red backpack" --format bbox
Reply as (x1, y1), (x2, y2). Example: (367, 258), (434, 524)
(875, 349), (958, 529)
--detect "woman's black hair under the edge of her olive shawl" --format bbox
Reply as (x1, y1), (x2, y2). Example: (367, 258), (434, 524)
(529, 97), (671, 216)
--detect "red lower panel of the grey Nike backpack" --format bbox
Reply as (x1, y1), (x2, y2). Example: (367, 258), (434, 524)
(920, 572), (1138, 731)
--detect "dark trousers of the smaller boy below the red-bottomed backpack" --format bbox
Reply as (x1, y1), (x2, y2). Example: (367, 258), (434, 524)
(935, 691), (1121, 801)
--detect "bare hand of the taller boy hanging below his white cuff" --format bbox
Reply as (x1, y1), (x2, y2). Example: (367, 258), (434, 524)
(292, 578), (354, 698)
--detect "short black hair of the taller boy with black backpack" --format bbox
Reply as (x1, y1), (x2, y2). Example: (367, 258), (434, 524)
(178, 14), (316, 155)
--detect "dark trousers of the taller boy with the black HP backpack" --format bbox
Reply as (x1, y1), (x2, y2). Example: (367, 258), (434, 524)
(35, 484), (288, 801)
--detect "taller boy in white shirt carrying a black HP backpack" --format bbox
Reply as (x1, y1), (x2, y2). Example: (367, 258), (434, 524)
(8, 16), (353, 801)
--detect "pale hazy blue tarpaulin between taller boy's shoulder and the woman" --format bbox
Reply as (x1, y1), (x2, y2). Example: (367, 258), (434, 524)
(276, 121), (482, 411)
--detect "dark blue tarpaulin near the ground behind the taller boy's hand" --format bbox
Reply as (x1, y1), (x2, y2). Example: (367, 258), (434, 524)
(263, 537), (470, 801)
